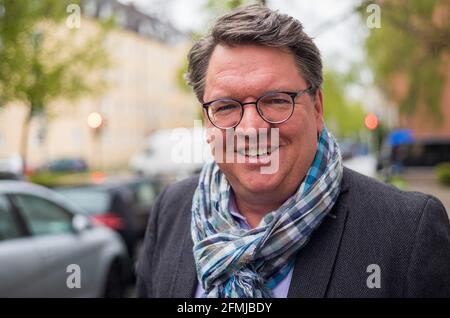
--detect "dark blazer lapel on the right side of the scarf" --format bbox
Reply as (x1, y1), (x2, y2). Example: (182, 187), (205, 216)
(288, 169), (348, 298)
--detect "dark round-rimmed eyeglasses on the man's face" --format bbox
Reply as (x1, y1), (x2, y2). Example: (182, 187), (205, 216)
(202, 86), (312, 129)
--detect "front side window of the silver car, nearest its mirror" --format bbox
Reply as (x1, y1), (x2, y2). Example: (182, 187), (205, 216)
(14, 195), (72, 235)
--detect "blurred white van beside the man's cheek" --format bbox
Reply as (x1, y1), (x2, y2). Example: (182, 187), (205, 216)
(129, 128), (213, 179)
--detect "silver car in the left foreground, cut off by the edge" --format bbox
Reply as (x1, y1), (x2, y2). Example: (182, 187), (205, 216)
(0, 180), (132, 297)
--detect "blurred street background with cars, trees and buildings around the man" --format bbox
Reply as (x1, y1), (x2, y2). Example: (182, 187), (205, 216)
(0, 0), (450, 297)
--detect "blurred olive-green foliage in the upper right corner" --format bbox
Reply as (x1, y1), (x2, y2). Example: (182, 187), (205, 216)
(360, 0), (450, 123)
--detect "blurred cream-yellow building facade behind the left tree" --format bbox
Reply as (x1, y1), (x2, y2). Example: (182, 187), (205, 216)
(0, 0), (199, 169)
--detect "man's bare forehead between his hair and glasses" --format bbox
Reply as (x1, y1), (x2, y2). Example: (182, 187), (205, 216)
(204, 45), (305, 100)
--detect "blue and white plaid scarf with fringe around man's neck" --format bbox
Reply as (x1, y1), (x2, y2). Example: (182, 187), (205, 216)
(191, 128), (343, 298)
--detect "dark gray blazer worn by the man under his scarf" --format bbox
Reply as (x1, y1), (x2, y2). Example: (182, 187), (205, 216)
(137, 168), (450, 298)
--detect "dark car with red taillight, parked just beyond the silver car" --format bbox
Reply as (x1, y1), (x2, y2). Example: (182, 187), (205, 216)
(56, 178), (161, 257)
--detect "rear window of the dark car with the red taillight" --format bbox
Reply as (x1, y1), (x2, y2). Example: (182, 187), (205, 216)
(58, 188), (111, 214)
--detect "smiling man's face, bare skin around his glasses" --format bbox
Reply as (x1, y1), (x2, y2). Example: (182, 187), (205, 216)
(203, 45), (323, 196)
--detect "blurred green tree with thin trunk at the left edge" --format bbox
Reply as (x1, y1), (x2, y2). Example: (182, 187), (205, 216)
(0, 0), (112, 168)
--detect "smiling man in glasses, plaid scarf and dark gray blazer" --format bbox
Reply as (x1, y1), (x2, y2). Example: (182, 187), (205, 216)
(138, 6), (450, 298)
